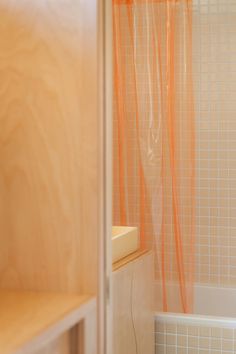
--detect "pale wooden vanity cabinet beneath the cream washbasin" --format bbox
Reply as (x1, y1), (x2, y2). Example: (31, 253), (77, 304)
(113, 252), (154, 354)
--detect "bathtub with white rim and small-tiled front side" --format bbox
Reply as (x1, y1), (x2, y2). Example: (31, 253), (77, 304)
(155, 285), (236, 354)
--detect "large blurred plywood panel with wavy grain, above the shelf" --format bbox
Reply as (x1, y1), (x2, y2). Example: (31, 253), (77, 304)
(0, 0), (98, 292)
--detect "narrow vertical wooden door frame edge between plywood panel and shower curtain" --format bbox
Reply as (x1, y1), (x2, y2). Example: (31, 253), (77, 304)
(98, 0), (113, 354)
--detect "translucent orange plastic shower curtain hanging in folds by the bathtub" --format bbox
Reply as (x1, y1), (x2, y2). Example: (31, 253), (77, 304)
(113, 0), (195, 313)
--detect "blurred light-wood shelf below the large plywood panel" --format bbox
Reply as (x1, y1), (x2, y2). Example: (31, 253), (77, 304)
(0, 291), (96, 354)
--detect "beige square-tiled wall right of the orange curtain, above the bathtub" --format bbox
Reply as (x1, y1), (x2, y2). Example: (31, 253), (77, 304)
(193, 0), (236, 285)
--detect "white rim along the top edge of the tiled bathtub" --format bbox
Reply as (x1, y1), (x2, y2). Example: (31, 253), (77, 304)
(155, 312), (236, 329)
